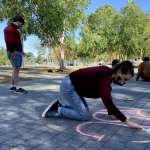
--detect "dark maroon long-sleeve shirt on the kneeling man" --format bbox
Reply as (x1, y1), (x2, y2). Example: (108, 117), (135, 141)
(70, 66), (126, 122)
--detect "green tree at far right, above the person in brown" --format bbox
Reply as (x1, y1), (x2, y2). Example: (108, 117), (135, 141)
(119, 2), (150, 58)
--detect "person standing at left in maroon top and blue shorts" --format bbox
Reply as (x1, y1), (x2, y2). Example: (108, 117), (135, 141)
(4, 15), (27, 93)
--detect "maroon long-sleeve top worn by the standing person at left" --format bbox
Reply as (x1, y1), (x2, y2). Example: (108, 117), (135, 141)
(4, 23), (23, 52)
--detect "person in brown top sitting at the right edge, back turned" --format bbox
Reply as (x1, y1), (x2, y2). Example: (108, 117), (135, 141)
(136, 56), (150, 81)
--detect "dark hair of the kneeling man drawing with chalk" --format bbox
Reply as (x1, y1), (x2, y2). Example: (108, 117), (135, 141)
(113, 60), (134, 76)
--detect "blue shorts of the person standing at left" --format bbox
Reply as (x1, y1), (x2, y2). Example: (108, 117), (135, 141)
(7, 52), (23, 69)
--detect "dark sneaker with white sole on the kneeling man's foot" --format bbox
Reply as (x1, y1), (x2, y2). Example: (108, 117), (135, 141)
(42, 100), (62, 118)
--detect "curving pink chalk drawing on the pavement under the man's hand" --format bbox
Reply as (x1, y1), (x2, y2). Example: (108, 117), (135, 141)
(76, 107), (150, 144)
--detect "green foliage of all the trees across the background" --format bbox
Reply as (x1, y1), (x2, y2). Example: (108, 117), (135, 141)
(0, 0), (150, 62)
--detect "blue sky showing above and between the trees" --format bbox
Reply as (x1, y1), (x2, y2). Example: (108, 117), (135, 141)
(0, 0), (150, 55)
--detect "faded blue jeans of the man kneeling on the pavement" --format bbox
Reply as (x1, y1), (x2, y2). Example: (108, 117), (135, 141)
(60, 75), (91, 121)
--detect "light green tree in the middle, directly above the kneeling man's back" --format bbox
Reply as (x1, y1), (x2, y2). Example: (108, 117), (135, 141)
(80, 5), (118, 61)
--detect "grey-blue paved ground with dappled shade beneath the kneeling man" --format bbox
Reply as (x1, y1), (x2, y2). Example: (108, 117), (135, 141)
(0, 76), (150, 150)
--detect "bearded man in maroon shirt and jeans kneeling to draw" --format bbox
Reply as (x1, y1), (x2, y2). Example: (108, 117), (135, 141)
(42, 61), (142, 129)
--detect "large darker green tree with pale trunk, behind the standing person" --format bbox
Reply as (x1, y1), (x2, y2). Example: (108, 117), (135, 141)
(0, 0), (88, 69)
